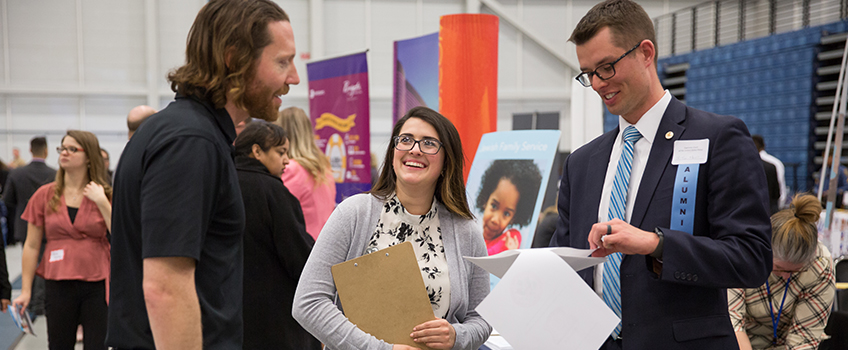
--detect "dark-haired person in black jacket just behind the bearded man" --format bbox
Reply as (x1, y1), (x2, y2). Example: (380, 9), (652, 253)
(235, 120), (321, 350)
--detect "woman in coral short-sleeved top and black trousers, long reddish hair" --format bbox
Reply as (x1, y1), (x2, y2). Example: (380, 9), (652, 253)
(14, 130), (112, 350)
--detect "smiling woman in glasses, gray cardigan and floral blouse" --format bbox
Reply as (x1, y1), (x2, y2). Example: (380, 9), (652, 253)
(293, 107), (492, 350)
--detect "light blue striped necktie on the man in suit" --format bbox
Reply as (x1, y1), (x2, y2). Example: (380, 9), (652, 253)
(604, 125), (642, 339)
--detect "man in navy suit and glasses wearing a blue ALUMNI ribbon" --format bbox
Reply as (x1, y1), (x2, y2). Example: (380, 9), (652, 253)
(551, 0), (772, 350)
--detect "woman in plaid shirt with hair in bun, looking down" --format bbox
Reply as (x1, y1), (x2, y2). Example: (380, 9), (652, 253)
(727, 194), (836, 350)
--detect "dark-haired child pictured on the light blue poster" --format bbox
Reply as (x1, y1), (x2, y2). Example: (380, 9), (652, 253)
(477, 159), (542, 255)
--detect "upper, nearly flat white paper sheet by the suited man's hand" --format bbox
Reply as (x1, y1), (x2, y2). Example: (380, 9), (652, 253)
(465, 247), (606, 278)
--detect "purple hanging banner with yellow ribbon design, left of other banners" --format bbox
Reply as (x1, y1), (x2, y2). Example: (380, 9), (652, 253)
(306, 52), (371, 203)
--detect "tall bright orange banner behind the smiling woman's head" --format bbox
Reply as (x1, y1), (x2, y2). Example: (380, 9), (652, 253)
(439, 14), (498, 180)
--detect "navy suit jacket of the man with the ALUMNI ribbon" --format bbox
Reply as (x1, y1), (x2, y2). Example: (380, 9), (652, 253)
(551, 98), (772, 350)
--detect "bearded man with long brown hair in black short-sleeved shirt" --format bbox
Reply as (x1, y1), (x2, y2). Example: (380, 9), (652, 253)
(106, 0), (300, 349)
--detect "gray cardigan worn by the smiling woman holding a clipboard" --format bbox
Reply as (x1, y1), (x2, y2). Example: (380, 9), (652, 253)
(292, 194), (492, 350)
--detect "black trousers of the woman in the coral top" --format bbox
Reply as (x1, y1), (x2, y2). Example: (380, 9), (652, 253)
(44, 280), (107, 350)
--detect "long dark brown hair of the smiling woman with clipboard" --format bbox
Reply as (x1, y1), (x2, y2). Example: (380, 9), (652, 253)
(369, 107), (474, 219)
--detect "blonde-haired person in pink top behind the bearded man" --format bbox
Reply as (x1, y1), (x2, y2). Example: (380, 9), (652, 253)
(276, 107), (336, 239)
